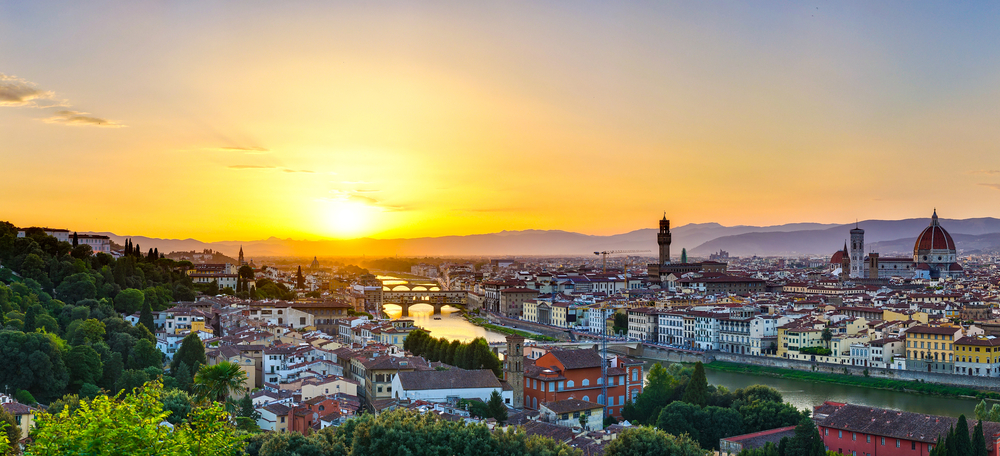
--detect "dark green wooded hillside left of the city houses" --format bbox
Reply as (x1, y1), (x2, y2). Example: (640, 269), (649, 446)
(0, 222), (195, 404)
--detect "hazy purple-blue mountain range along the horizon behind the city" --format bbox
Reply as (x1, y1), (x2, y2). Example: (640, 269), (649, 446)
(82, 218), (1000, 258)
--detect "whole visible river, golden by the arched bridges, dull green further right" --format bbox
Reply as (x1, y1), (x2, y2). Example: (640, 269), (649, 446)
(378, 276), (992, 417)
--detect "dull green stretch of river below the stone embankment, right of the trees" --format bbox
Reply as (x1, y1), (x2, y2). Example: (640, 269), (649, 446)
(646, 361), (992, 417)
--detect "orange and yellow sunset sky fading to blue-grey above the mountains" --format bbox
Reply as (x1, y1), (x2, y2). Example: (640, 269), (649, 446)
(0, 1), (1000, 241)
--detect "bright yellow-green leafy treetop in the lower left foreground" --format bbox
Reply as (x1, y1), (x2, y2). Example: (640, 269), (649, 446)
(30, 381), (242, 456)
